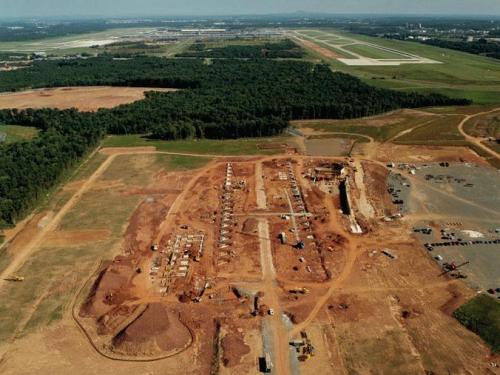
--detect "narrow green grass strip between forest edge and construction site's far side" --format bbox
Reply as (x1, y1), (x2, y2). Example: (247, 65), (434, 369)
(103, 135), (290, 155)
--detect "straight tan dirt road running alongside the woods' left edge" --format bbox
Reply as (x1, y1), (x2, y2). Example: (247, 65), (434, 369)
(0, 155), (115, 289)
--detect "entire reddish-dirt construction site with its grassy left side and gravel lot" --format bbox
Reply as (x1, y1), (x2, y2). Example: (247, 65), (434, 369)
(0, 134), (500, 374)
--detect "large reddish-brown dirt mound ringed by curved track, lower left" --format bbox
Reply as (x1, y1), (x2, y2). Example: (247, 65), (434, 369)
(112, 303), (192, 356)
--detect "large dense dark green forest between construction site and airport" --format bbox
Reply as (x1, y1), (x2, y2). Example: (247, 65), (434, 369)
(0, 57), (467, 225)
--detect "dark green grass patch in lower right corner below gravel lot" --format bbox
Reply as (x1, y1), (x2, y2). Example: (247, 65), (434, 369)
(454, 294), (500, 353)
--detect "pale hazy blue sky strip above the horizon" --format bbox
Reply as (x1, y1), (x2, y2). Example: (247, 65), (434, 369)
(0, 0), (500, 18)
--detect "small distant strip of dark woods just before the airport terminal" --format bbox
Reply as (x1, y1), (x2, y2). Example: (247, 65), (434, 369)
(177, 39), (304, 59)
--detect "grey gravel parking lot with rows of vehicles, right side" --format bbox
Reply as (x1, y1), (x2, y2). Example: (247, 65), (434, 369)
(388, 163), (500, 290)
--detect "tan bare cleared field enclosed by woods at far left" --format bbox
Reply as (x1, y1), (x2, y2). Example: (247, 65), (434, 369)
(0, 86), (176, 111)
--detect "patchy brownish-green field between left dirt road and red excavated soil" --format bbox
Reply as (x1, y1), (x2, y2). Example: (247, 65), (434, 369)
(0, 154), (211, 342)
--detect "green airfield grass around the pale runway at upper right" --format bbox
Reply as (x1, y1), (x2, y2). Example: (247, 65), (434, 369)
(298, 29), (500, 104)
